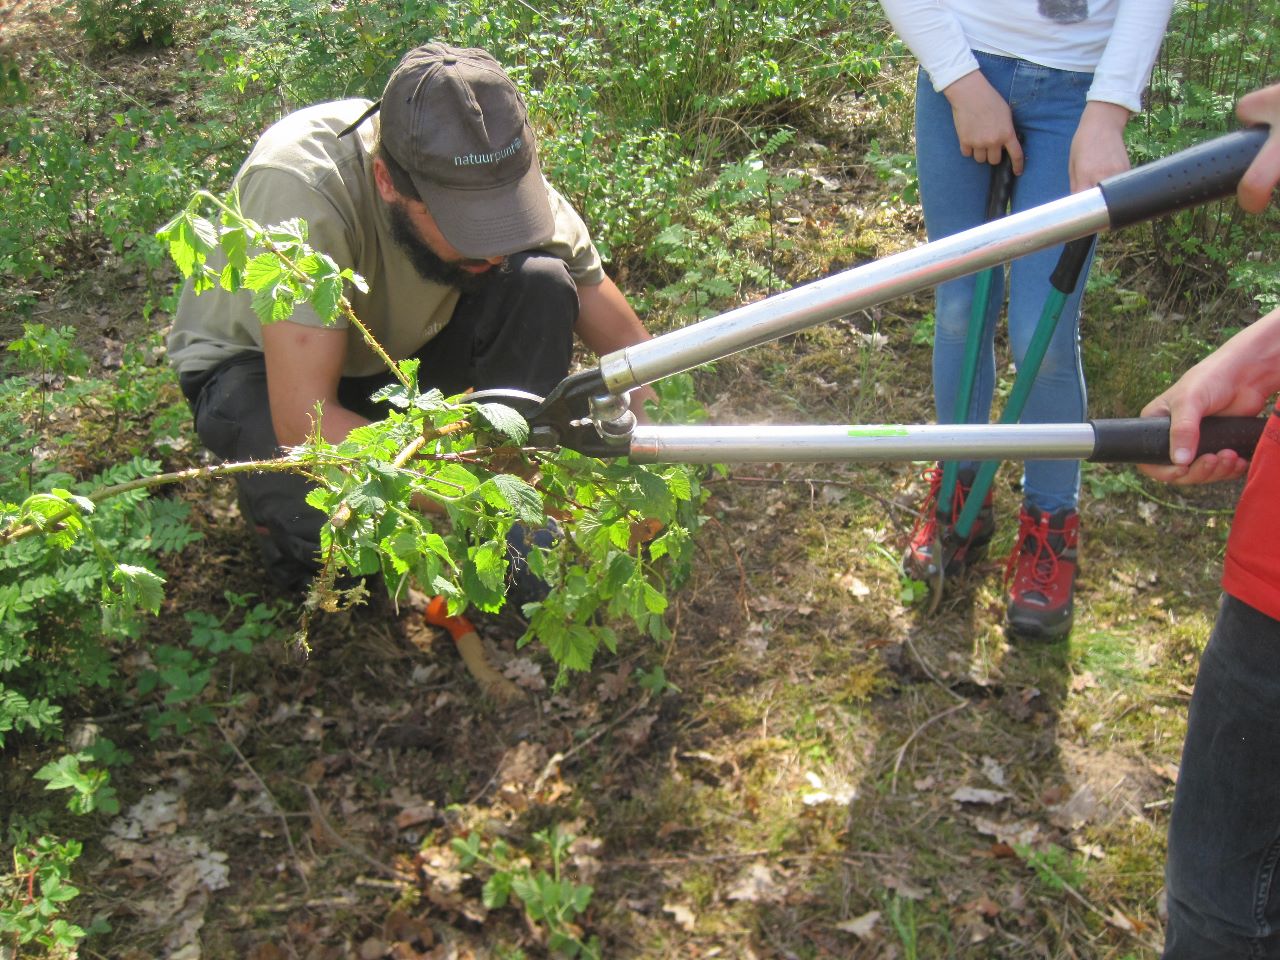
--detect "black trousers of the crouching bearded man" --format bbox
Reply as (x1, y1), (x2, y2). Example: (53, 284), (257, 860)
(180, 253), (579, 590)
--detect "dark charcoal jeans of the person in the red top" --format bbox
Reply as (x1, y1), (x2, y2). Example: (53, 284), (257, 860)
(1164, 596), (1280, 960)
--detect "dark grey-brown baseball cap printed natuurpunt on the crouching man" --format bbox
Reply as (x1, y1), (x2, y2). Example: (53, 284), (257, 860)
(380, 44), (556, 257)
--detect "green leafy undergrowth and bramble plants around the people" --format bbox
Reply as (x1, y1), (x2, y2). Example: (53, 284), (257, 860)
(0, 0), (1280, 957)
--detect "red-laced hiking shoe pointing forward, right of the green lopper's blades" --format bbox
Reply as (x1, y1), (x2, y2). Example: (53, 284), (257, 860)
(1005, 507), (1080, 640)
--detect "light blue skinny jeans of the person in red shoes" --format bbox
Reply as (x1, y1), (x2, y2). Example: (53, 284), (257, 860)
(915, 51), (1093, 512)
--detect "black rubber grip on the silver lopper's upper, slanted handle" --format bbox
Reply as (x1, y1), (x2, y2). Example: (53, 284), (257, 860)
(1098, 125), (1270, 230)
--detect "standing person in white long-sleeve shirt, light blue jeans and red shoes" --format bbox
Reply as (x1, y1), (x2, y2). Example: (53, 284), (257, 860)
(882, 0), (1172, 639)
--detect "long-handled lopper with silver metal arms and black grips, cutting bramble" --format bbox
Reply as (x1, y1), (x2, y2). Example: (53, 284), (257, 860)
(471, 127), (1267, 473)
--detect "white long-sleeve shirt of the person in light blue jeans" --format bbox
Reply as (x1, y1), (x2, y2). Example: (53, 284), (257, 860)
(881, 0), (1172, 113)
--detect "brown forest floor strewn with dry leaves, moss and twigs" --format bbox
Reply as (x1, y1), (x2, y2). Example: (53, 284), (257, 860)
(0, 3), (1259, 960)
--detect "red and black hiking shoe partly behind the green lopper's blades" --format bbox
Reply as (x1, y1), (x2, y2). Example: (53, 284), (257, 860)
(902, 463), (996, 582)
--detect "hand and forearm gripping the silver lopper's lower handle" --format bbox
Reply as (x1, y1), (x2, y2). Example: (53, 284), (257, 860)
(1138, 310), (1280, 485)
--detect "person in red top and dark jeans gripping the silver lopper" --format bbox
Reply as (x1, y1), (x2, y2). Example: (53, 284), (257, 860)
(1140, 83), (1280, 960)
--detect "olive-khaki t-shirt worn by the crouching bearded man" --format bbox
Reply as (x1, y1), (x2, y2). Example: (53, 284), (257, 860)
(168, 100), (604, 376)
